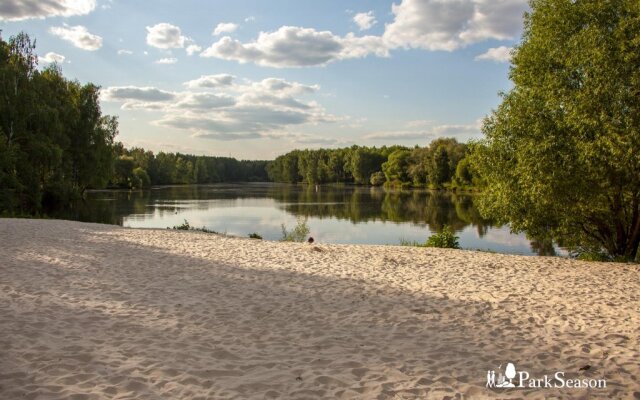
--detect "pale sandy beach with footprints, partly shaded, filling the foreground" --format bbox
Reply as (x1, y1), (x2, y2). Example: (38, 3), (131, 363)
(0, 219), (640, 399)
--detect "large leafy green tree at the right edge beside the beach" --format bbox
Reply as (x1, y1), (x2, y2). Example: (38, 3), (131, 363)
(474, 0), (640, 260)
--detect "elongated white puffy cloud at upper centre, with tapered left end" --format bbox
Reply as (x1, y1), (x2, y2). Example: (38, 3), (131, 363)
(200, 26), (388, 68)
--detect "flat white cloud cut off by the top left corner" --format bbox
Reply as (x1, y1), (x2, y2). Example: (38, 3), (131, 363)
(0, 0), (96, 21)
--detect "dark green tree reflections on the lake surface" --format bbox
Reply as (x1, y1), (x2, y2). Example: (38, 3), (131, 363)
(49, 183), (555, 255)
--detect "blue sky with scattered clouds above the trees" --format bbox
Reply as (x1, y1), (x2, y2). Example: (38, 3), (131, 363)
(0, 0), (527, 159)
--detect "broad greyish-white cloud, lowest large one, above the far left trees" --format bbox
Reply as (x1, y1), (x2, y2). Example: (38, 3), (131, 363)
(102, 74), (338, 140)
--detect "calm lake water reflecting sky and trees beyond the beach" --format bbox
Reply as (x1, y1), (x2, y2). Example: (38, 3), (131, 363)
(66, 183), (554, 255)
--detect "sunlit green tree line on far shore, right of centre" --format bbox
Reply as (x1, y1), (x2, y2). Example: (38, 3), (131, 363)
(267, 138), (482, 189)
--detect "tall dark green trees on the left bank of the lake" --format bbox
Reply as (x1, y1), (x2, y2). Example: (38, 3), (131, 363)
(0, 34), (117, 212)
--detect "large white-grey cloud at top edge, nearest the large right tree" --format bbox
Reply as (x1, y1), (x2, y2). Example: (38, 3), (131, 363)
(383, 0), (527, 51)
